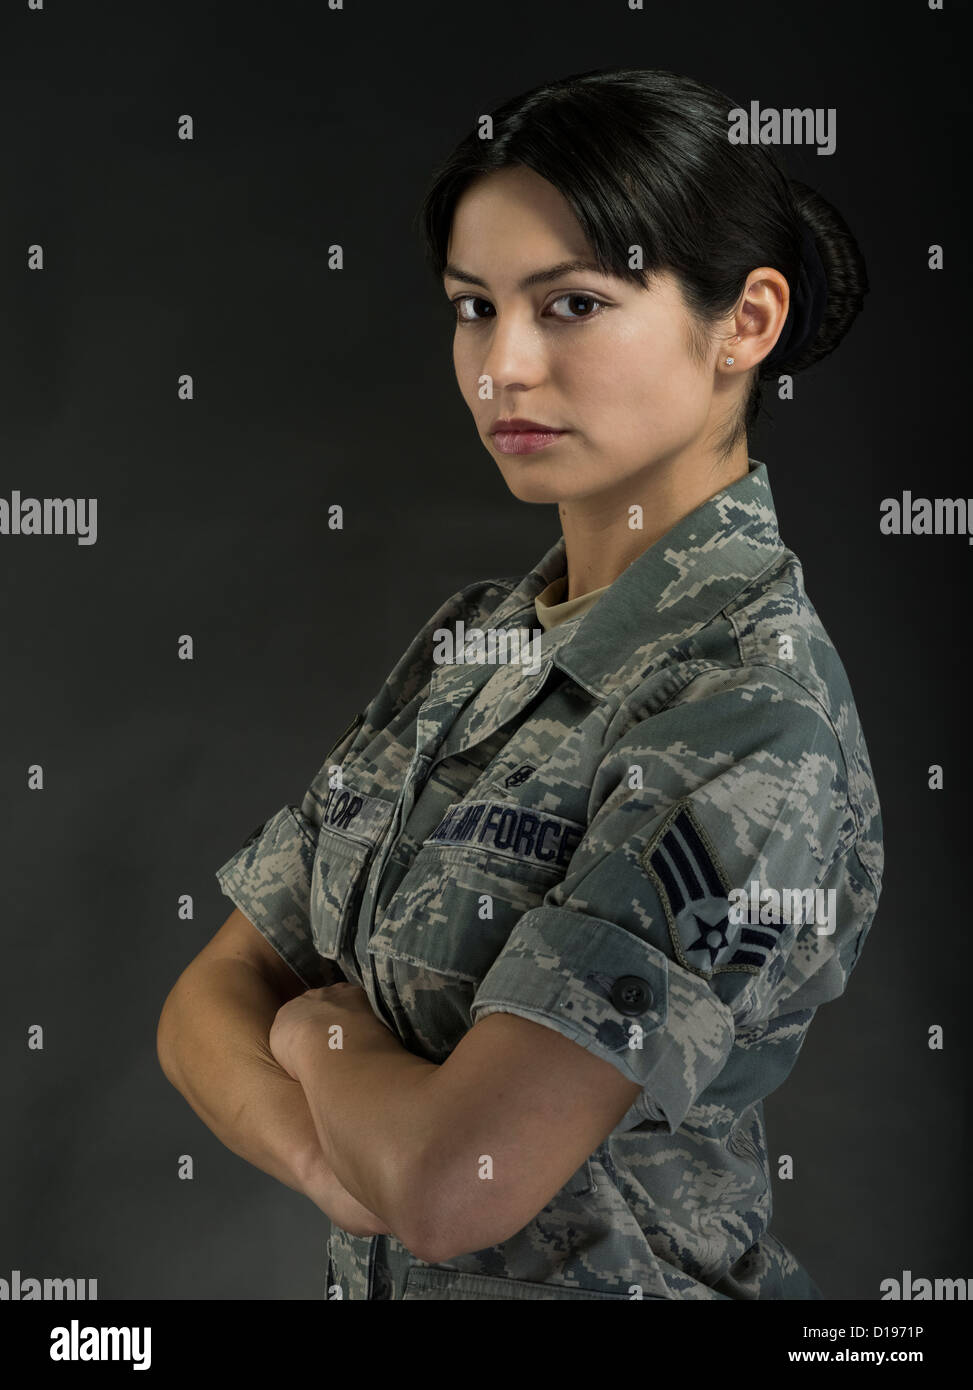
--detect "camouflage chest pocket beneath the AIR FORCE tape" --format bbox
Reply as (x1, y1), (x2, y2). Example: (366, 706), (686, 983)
(368, 799), (585, 998)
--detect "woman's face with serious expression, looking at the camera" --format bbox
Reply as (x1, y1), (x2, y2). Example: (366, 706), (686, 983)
(443, 167), (737, 502)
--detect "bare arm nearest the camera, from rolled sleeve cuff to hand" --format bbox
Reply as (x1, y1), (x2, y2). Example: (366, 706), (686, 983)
(280, 986), (641, 1264)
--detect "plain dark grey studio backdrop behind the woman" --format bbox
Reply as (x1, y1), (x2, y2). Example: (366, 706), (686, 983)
(0, 0), (973, 1307)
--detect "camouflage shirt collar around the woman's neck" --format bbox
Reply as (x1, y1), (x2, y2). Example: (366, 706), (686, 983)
(492, 459), (784, 695)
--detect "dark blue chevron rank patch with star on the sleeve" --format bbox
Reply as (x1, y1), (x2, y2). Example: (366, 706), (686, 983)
(639, 801), (780, 980)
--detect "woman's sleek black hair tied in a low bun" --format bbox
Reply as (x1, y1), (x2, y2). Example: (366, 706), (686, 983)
(417, 68), (869, 456)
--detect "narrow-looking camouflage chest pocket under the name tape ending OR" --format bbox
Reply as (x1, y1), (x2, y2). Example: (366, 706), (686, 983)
(310, 781), (395, 960)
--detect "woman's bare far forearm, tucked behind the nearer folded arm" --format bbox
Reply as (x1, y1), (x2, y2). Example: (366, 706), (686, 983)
(157, 958), (388, 1234)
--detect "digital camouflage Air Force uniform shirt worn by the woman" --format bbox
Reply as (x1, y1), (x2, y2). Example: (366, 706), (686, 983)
(217, 460), (883, 1300)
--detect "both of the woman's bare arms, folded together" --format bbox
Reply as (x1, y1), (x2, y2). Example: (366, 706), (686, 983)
(157, 909), (639, 1264)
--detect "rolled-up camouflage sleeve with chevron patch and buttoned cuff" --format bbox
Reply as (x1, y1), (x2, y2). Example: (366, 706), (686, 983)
(471, 671), (853, 1133)
